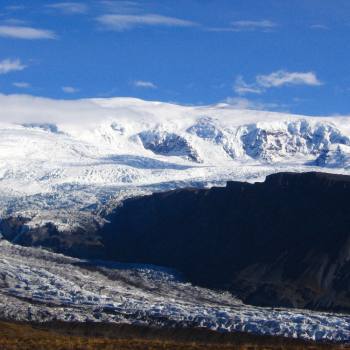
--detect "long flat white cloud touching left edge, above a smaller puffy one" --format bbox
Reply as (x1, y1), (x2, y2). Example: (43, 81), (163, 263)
(0, 26), (56, 40)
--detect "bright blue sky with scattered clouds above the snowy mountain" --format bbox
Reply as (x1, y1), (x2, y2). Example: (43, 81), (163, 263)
(0, 0), (350, 115)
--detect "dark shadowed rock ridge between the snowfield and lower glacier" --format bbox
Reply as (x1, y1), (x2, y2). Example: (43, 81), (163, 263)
(101, 173), (350, 312)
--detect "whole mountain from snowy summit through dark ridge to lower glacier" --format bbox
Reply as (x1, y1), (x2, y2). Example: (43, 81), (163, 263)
(0, 94), (350, 342)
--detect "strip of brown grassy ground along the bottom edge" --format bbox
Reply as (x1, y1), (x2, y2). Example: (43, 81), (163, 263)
(0, 322), (350, 350)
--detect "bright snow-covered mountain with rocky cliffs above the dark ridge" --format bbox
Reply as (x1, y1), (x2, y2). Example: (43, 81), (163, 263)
(0, 95), (350, 229)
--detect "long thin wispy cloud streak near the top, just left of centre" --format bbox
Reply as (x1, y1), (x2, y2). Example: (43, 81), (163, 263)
(97, 14), (196, 31)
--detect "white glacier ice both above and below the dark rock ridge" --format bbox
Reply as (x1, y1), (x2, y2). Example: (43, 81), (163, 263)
(0, 94), (350, 342)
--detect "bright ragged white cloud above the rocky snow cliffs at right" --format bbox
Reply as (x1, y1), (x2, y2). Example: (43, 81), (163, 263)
(233, 70), (322, 95)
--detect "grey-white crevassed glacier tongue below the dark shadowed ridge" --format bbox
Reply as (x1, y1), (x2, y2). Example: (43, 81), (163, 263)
(0, 240), (350, 341)
